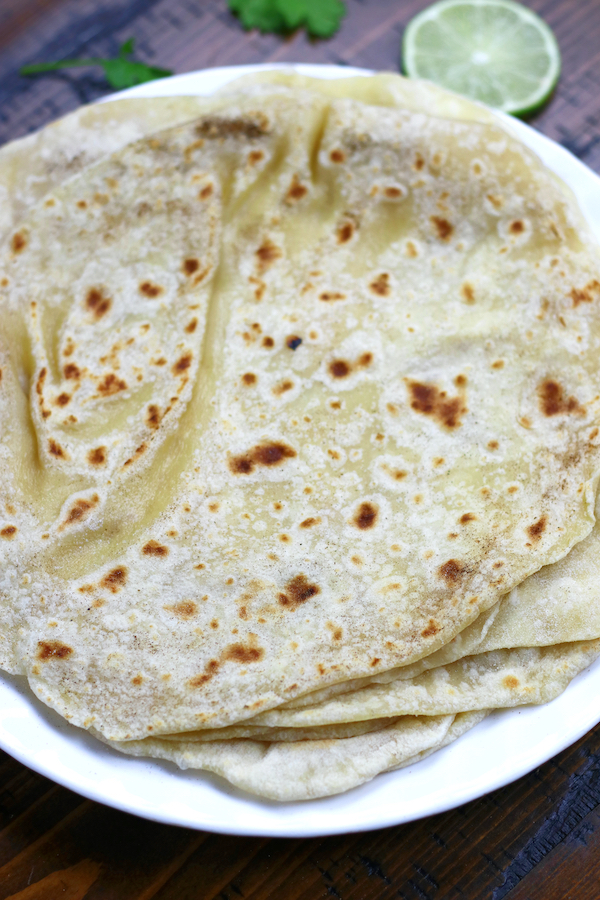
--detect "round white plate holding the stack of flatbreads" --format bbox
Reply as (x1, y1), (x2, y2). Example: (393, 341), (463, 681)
(0, 65), (600, 837)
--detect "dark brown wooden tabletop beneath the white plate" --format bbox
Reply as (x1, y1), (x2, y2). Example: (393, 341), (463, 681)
(0, 0), (600, 900)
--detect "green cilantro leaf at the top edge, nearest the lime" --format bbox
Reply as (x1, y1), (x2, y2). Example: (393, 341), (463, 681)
(227, 0), (346, 38)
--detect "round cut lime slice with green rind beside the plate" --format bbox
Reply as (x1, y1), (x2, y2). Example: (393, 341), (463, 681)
(402, 0), (560, 116)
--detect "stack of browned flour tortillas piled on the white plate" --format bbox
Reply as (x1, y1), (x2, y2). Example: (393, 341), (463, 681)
(0, 74), (600, 800)
